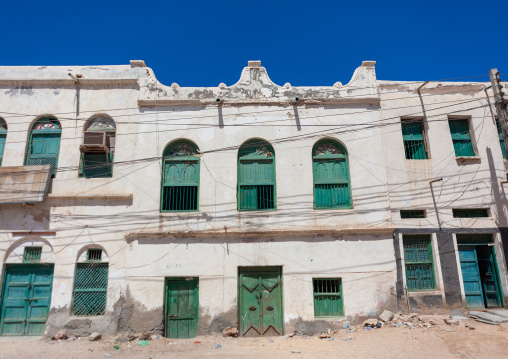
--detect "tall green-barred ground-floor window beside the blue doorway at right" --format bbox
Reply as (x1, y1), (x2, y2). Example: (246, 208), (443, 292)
(402, 234), (436, 292)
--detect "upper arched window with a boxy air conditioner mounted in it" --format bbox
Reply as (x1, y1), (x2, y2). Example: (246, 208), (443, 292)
(79, 116), (116, 178)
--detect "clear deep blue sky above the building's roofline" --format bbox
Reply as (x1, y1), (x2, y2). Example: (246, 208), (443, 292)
(0, 0), (508, 86)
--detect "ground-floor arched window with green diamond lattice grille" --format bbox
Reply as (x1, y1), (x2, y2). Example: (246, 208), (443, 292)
(72, 248), (109, 316)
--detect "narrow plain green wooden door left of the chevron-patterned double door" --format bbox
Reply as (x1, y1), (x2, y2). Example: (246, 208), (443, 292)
(165, 278), (199, 339)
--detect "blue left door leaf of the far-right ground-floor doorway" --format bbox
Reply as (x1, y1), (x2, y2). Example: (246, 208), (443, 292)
(459, 245), (485, 309)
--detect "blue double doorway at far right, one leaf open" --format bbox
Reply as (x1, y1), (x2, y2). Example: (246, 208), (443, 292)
(459, 245), (501, 309)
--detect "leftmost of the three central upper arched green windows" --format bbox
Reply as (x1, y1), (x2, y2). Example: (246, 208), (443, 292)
(161, 140), (200, 212)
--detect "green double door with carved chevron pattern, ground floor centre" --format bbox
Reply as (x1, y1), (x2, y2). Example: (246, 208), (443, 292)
(238, 267), (284, 337)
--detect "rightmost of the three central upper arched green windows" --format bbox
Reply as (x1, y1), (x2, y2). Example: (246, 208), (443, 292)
(312, 140), (353, 209)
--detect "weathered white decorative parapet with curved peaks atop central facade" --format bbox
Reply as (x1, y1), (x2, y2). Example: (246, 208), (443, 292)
(138, 61), (380, 107)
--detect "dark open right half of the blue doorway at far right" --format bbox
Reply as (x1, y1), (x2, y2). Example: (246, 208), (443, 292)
(476, 246), (502, 308)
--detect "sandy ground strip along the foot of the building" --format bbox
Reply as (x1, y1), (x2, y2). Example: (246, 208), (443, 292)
(0, 321), (508, 359)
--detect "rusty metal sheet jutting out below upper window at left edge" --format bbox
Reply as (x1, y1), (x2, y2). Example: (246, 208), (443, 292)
(0, 165), (52, 204)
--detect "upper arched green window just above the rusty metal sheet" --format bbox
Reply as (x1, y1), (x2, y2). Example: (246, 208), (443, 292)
(26, 117), (62, 177)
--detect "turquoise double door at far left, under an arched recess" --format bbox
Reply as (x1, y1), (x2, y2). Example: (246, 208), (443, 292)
(0, 264), (53, 335)
